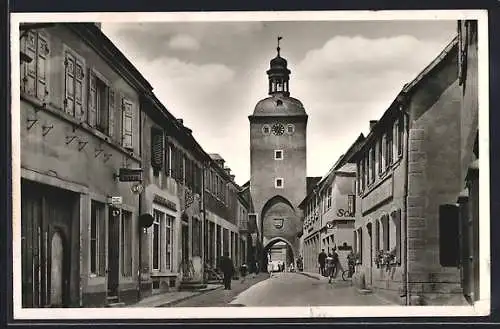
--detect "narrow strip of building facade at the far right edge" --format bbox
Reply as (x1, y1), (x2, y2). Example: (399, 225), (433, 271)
(455, 20), (480, 303)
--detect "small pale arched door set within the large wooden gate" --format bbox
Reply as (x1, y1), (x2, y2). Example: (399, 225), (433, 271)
(50, 230), (65, 306)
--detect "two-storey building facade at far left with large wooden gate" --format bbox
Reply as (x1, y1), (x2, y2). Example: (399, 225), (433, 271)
(20, 23), (151, 307)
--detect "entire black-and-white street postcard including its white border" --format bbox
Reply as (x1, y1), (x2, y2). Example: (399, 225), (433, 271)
(11, 10), (490, 319)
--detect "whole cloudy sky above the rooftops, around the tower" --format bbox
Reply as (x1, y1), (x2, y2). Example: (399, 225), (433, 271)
(102, 21), (456, 184)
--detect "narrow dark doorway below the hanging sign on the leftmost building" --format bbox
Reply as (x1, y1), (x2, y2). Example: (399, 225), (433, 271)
(107, 207), (120, 297)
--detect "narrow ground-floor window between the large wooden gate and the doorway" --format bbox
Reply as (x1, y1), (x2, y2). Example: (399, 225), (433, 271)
(89, 200), (106, 277)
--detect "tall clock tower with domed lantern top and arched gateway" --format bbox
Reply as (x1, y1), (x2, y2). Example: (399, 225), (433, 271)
(249, 40), (307, 267)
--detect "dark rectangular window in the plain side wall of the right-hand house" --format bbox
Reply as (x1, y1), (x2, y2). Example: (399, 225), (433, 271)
(439, 205), (460, 266)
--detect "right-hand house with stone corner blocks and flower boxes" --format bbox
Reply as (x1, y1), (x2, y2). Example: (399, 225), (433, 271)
(355, 38), (475, 305)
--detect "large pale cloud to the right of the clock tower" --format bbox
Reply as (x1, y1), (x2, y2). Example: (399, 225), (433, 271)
(290, 35), (451, 175)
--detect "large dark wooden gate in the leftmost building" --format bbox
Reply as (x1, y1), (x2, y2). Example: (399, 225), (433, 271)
(21, 182), (75, 307)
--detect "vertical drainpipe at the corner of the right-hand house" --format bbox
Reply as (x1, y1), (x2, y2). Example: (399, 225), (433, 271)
(399, 95), (410, 306)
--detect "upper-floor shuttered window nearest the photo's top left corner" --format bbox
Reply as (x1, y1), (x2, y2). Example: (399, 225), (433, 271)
(20, 31), (50, 101)
